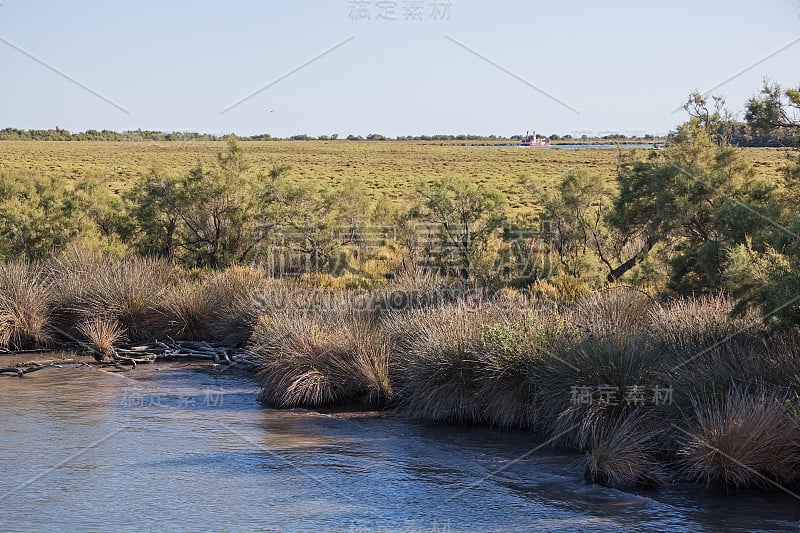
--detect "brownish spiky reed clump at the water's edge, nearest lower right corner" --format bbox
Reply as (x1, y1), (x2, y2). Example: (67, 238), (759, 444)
(679, 386), (800, 488)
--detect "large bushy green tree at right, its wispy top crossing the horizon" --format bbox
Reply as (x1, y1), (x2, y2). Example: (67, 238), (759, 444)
(610, 95), (769, 294)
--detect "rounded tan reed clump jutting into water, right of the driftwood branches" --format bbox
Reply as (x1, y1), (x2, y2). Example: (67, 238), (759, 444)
(249, 303), (392, 408)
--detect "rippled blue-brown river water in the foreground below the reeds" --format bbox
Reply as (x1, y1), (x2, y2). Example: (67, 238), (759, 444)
(0, 365), (800, 532)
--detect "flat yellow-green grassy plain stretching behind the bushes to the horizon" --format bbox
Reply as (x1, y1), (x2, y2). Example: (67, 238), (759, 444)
(0, 140), (787, 212)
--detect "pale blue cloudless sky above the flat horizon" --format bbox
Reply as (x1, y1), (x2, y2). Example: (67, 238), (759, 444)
(0, 0), (800, 136)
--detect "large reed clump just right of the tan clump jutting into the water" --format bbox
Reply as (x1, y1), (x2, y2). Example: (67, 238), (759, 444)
(384, 303), (570, 427)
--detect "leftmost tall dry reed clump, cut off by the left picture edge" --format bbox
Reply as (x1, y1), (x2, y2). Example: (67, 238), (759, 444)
(0, 260), (54, 350)
